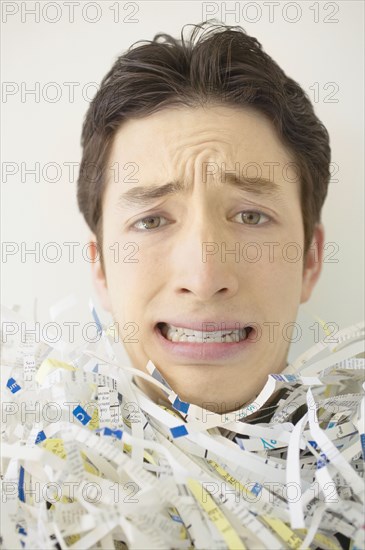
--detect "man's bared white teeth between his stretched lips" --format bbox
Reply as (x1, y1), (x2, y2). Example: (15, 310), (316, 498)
(162, 323), (247, 342)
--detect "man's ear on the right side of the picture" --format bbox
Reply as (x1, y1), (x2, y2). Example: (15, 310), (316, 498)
(300, 224), (324, 304)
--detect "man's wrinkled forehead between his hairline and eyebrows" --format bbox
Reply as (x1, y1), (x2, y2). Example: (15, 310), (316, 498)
(105, 104), (294, 187)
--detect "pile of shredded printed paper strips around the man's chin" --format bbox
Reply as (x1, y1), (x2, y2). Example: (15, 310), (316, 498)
(1, 302), (365, 550)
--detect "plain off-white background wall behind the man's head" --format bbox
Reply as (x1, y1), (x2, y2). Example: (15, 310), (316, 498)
(1, 0), (364, 364)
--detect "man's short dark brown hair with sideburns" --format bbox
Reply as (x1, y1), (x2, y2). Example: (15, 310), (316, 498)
(77, 20), (331, 266)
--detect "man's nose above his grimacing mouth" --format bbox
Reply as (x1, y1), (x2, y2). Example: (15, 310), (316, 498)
(172, 213), (239, 302)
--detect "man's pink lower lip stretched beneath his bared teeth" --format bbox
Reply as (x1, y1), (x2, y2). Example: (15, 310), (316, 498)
(154, 321), (253, 361)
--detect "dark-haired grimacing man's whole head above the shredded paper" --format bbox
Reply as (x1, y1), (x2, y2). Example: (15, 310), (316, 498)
(78, 23), (330, 412)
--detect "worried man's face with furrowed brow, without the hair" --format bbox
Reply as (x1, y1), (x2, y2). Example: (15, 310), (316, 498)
(93, 105), (323, 411)
